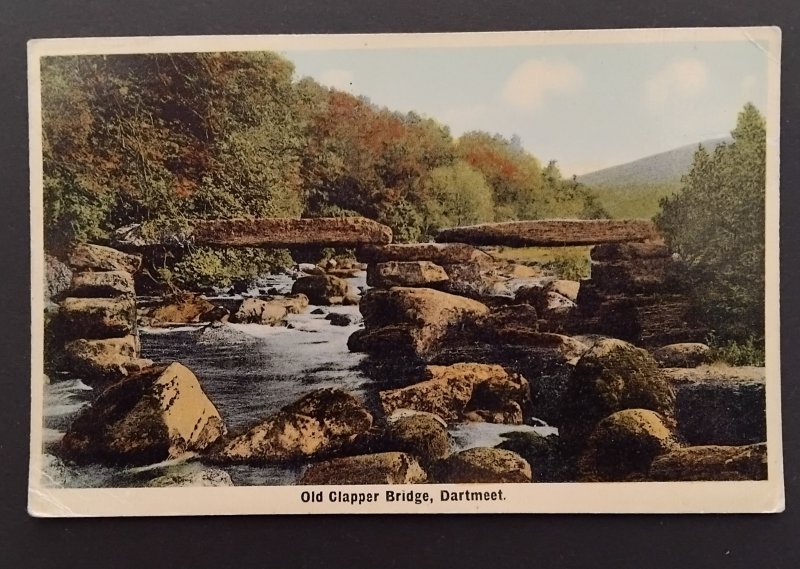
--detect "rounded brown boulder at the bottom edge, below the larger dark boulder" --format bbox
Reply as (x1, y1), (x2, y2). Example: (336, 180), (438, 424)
(581, 409), (678, 481)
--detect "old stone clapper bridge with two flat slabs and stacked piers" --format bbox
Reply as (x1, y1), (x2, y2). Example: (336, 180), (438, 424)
(109, 217), (707, 346)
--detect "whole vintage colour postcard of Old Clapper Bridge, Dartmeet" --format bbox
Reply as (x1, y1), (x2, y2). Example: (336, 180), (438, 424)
(28, 27), (784, 516)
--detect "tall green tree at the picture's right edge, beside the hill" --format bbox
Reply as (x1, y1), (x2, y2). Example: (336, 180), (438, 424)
(656, 104), (766, 345)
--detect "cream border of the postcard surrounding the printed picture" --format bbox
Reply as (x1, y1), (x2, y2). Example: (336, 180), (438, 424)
(28, 27), (784, 517)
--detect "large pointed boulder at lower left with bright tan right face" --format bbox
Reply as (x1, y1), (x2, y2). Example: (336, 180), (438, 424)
(61, 363), (225, 465)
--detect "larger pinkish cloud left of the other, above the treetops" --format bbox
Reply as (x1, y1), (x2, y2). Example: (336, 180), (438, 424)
(502, 59), (584, 111)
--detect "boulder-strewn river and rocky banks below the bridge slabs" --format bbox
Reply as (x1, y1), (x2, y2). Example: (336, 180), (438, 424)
(44, 237), (766, 486)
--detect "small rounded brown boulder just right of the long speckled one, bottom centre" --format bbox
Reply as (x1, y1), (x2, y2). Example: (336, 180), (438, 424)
(387, 413), (450, 464)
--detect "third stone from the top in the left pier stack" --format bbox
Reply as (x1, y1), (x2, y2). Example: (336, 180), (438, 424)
(58, 297), (136, 339)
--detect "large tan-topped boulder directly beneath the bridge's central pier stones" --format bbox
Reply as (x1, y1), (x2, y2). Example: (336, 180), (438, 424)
(349, 287), (489, 359)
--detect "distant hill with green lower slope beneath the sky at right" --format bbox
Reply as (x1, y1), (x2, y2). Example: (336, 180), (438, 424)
(578, 138), (730, 218)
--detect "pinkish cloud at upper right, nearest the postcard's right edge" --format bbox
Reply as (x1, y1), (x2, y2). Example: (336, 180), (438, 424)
(644, 58), (708, 110)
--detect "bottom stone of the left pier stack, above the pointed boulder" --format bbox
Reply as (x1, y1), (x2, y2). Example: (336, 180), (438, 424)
(64, 335), (153, 384)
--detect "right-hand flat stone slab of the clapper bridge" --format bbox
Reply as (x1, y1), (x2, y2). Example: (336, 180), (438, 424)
(436, 219), (659, 247)
